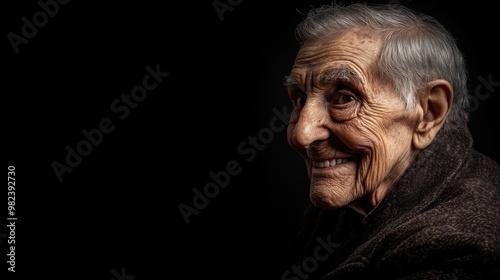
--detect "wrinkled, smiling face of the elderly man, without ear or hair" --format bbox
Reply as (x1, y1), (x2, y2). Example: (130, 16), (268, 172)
(287, 31), (417, 209)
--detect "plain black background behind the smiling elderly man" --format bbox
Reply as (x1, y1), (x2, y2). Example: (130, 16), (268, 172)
(0, 0), (500, 280)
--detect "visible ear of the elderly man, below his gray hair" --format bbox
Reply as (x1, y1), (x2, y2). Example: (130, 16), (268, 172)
(413, 80), (453, 150)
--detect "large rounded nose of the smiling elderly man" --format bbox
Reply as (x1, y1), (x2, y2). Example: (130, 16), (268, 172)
(292, 99), (330, 148)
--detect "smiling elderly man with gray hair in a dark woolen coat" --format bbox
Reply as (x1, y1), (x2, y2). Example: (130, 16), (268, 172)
(282, 4), (500, 280)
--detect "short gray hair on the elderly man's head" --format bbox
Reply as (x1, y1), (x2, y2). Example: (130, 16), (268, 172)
(295, 3), (470, 130)
